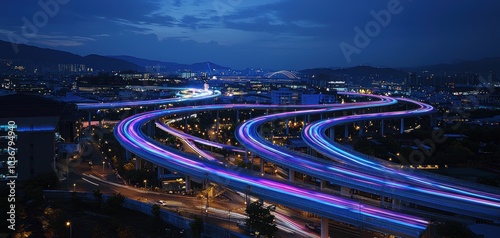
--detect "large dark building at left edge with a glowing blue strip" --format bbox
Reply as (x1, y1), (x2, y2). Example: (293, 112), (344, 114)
(0, 94), (75, 181)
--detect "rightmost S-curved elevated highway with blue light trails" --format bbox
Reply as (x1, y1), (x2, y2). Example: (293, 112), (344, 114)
(302, 98), (500, 201)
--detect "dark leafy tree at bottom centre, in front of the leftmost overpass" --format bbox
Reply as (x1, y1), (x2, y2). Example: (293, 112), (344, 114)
(245, 202), (278, 237)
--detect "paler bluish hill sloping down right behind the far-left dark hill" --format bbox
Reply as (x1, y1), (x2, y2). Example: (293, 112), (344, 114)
(108, 55), (230, 72)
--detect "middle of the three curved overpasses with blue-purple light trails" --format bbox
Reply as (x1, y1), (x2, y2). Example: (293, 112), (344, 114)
(236, 96), (500, 221)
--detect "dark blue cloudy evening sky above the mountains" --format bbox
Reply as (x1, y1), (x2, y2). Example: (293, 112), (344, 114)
(0, 0), (500, 69)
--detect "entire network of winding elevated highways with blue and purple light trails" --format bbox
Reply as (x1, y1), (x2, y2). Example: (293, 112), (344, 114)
(78, 90), (500, 236)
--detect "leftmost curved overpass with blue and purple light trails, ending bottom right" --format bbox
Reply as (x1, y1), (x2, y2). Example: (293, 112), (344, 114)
(114, 102), (428, 236)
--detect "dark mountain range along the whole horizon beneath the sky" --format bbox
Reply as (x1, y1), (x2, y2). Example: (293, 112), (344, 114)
(0, 40), (500, 78)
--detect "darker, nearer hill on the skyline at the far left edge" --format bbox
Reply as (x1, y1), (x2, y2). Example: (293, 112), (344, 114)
(0, 41), (139, 71)
